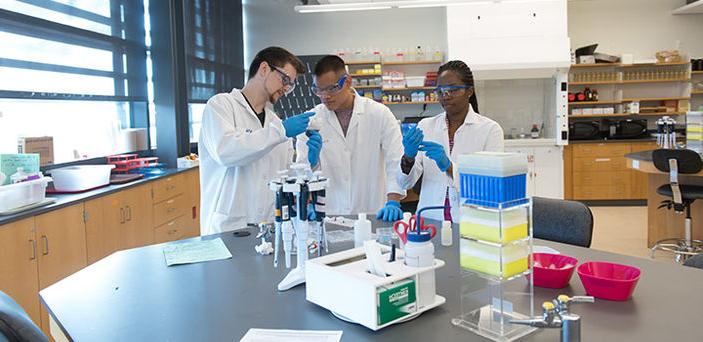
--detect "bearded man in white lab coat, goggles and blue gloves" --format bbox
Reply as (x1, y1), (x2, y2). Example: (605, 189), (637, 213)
(198, 47), (311, 235)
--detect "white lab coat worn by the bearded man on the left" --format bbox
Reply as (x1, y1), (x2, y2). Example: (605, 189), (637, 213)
(198, 89), (293, 235)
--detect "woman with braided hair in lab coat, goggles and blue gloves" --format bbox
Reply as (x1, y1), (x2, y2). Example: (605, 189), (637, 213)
(398, 61), (503, 222)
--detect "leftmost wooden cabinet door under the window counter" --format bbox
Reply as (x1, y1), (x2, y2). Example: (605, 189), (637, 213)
(0, 218), (40, 324)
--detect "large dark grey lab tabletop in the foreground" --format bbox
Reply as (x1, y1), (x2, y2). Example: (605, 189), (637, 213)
(40, 218), (703, 341)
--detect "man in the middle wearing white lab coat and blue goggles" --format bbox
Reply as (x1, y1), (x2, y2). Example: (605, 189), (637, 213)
(296, 55), (405, 221)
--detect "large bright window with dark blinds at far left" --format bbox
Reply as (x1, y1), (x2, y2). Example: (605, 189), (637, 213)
(0, 0), (149, 163)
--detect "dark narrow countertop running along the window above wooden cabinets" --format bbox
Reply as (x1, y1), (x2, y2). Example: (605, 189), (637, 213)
(0, 166), (197, 226)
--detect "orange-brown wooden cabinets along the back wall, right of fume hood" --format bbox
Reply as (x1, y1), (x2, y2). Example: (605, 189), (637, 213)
(564, 142), (656, 200)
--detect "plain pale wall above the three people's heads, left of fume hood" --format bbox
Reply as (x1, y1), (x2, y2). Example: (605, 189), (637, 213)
(243, 0), (447, 68)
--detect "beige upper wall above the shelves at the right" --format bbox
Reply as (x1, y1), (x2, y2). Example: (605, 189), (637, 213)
(568, 0), (703, 59)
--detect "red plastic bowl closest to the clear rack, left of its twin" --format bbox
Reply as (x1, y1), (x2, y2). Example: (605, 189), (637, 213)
(532, 253), (578, 289)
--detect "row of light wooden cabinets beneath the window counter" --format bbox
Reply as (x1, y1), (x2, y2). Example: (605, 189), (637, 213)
(0, 169), (200, 336)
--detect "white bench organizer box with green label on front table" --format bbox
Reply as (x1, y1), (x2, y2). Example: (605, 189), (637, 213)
(305, 241), (446, 330)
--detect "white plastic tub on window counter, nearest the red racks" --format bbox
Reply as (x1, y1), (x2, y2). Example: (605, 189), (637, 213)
(49, 165), (115, 192)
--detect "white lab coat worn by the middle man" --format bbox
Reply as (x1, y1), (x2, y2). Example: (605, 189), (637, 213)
(296, 94), (405, 215)
